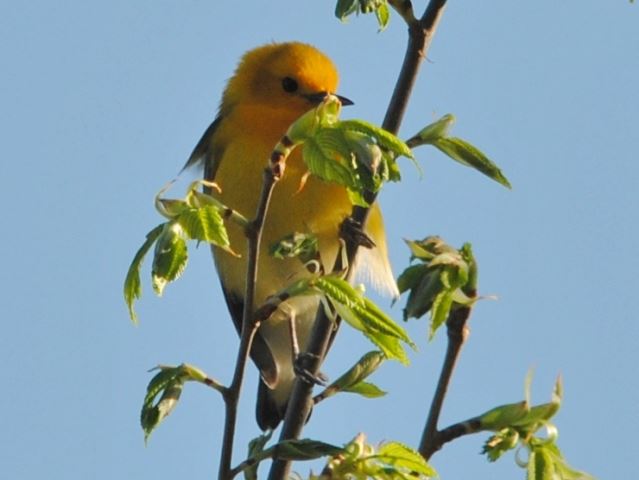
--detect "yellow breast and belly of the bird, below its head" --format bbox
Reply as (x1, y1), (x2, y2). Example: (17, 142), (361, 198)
(215, 105), (351, 305)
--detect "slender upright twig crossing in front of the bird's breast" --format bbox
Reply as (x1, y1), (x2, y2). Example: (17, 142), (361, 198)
(219, 167), (279, 480)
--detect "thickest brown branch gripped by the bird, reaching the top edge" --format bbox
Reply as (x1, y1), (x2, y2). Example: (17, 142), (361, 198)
(268, 0), (446, 480)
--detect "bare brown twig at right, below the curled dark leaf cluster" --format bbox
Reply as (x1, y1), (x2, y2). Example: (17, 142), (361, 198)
(419, 307), (471, 460)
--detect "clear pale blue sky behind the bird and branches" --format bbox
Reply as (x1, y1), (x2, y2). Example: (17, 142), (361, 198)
(0, 0), (639, 479)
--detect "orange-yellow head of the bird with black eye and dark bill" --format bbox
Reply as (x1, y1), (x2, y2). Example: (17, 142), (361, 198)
(220, 42), (352, 120)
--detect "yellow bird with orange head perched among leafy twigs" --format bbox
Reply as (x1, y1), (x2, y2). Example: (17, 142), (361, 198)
(186, 42), (397, 430)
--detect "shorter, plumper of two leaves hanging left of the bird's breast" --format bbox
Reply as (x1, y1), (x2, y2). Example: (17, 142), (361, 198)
(151, 222), (188, 296)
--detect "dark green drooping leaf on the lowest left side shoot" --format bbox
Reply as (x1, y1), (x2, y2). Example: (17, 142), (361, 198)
(140, 367), (185, 442)
